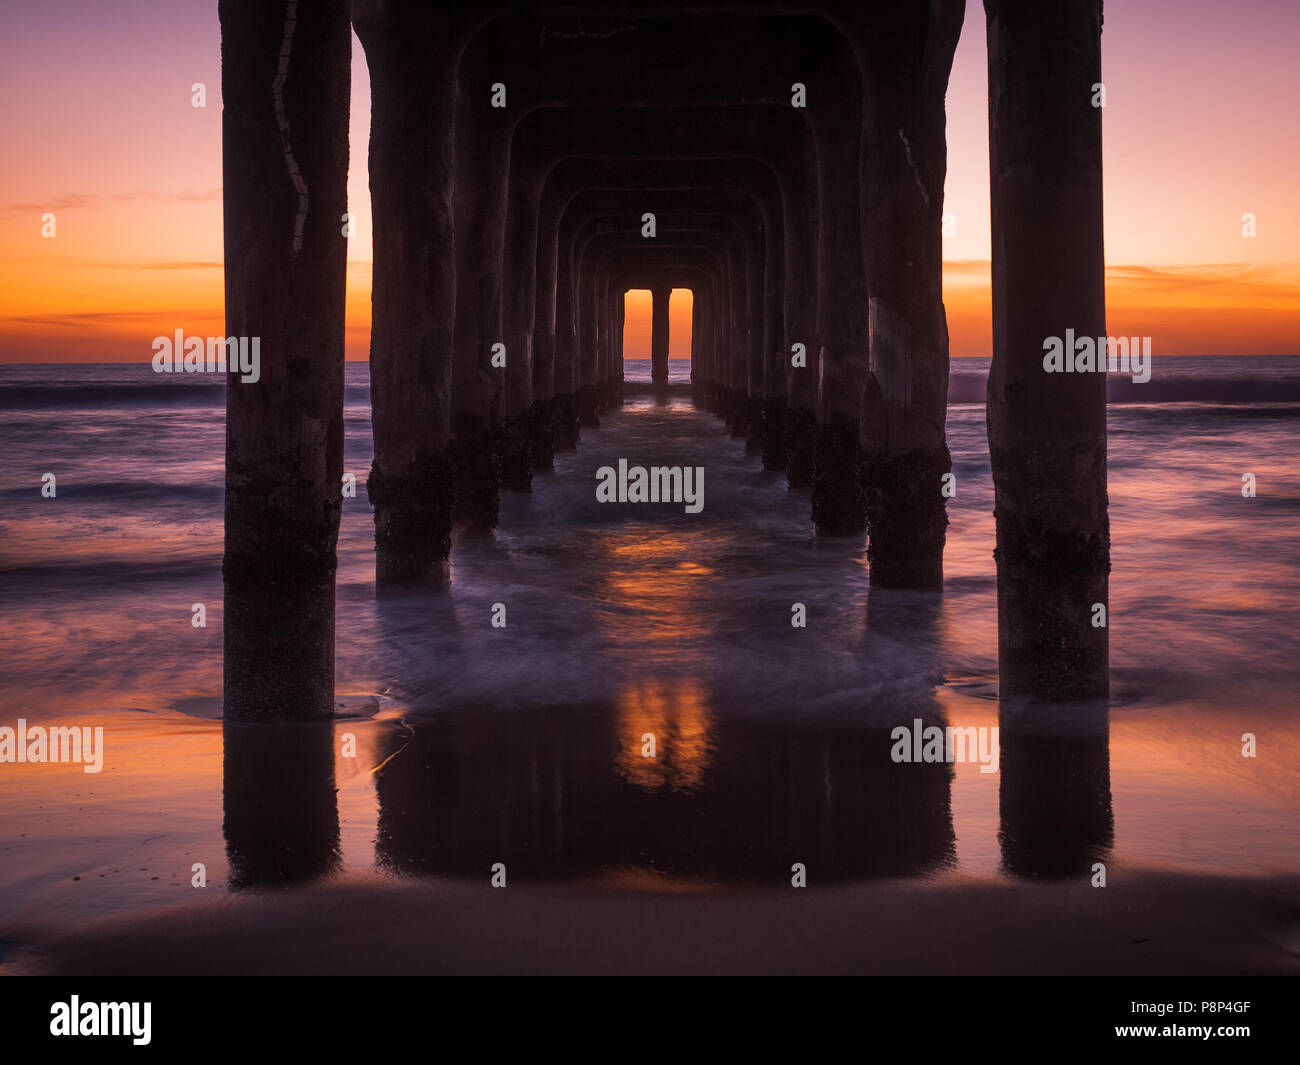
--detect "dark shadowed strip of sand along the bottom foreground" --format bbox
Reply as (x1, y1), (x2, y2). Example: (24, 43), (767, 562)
(0, 870), (1300, 975)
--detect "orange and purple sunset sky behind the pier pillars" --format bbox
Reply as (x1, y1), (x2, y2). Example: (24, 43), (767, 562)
(0, 0), (1300, 363)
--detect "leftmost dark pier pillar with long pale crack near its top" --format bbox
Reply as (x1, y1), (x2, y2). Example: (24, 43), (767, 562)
(220, 0), (351, 720)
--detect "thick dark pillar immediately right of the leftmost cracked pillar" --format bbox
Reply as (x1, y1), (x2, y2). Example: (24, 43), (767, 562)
(354, 4), (455, 589)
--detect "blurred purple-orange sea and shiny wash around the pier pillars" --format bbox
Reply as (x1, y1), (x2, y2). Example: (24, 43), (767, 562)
(0, 358), (1300, 912)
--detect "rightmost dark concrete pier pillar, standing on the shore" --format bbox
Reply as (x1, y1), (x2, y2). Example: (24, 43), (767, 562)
(984, 0), (1110, 698)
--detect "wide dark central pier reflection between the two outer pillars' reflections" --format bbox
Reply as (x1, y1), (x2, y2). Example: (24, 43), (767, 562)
(376, 685), (953, 884)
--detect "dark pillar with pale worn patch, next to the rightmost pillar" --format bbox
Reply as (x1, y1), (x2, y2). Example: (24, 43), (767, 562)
(854, 0), (965, 589)
